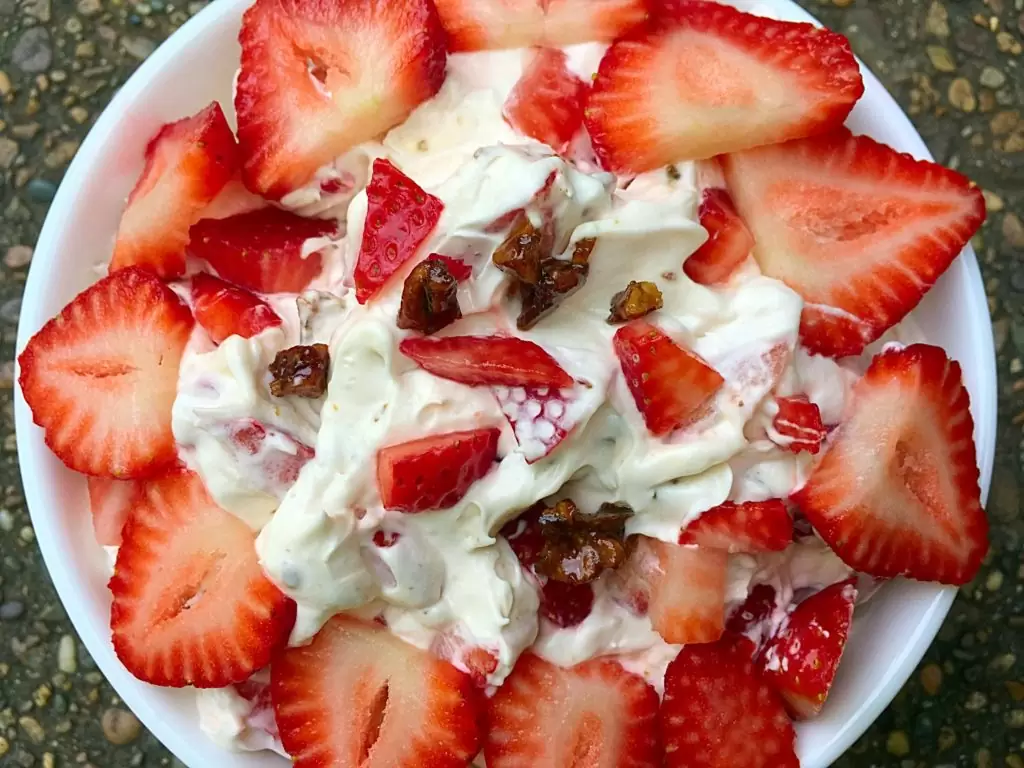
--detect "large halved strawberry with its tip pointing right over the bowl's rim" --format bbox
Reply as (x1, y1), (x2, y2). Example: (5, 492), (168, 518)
(722, 129), (985, 357)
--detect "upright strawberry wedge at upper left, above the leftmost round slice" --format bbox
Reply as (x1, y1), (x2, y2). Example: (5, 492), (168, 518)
(110, 102), (239, 280)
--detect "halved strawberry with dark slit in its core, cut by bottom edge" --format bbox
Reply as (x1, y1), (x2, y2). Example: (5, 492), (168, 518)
(270, 615), (480, 768)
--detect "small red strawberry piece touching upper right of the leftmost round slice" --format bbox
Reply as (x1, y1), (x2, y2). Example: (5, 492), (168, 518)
(191, 272), (282, 344)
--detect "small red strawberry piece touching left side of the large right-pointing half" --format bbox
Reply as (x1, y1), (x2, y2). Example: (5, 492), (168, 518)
(683, 188), (754, 286)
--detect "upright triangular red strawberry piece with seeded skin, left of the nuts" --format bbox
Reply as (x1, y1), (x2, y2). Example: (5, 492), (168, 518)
(354, 158), (444, 304)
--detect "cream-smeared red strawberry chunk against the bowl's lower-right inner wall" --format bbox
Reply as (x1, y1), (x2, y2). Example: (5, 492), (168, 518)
(761, 579), (857, 720)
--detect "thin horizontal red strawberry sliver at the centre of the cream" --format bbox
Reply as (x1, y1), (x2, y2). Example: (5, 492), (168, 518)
(398, 336), (572, 388)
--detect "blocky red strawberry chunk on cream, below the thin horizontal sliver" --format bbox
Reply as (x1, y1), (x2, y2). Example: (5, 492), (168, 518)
(377, 427), (501, 512)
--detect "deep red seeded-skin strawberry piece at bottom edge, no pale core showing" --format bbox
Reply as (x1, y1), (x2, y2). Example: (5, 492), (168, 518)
(660, 638), (800, 768)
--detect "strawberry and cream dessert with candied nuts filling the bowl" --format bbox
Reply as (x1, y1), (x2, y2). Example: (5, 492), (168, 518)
(19, 0), (987, 768)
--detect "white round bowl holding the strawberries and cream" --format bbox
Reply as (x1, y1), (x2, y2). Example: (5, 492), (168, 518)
(14, 0), (996, 768)
